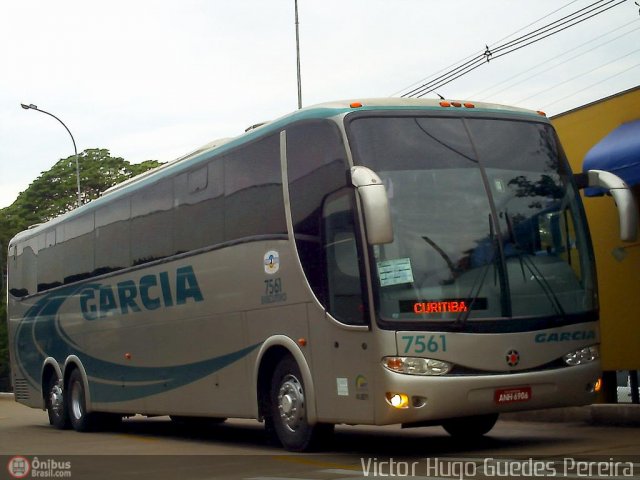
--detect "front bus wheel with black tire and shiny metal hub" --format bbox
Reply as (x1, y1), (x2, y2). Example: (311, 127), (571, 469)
(267, 356), (333, 452)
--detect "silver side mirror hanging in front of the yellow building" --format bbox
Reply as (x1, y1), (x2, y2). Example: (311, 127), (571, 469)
(586, 170), (638, 242)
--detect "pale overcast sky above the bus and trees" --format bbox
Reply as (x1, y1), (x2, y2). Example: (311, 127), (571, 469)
(0, 0), (640, 208)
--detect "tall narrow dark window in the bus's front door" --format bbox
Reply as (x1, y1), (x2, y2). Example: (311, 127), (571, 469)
(322, 189), (366, 325)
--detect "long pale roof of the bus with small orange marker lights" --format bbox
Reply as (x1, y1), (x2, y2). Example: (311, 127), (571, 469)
(9, 97), (544, 246)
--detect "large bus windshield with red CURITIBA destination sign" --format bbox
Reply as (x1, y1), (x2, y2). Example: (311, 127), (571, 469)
(347, 112), (596, 328)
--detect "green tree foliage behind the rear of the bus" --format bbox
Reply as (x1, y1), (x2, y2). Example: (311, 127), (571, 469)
(0, 148), (161, 392)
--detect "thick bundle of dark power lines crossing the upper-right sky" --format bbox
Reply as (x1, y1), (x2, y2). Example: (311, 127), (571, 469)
(402, 0), (627, 97)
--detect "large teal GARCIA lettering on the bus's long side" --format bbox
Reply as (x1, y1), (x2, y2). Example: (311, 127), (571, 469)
(80, 265), (204, 320)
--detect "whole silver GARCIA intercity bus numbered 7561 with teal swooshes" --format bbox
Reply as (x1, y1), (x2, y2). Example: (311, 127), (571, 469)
(8, 98), (637, 450)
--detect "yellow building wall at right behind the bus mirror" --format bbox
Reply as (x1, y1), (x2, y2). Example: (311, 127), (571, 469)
(551, 86), (640, 400)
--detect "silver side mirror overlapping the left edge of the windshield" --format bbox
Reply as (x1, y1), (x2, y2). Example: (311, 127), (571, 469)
(351, 166), (393, 245)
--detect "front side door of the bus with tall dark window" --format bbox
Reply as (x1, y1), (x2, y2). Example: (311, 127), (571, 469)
(312, 188), (375, 423)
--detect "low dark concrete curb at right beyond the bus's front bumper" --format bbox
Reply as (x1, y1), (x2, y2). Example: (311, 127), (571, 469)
(500, 404), (640, 427)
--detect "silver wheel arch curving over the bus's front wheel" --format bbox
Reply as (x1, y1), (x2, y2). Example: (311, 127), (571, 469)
(253, 335), (317, 425)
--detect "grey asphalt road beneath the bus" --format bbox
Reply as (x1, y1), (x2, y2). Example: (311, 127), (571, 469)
(0, 398), (640, 480)
